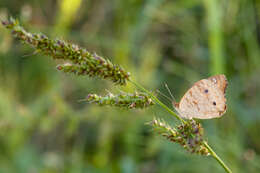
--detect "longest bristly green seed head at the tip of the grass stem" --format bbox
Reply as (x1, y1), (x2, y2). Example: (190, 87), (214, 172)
(2, 18), (130, 85)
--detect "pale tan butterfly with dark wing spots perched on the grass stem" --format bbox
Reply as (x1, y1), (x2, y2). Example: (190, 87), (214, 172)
(173, 74), (228, 119)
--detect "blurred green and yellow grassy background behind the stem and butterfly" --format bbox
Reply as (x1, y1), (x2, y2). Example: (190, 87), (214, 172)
(0, 0), (260, 173)
